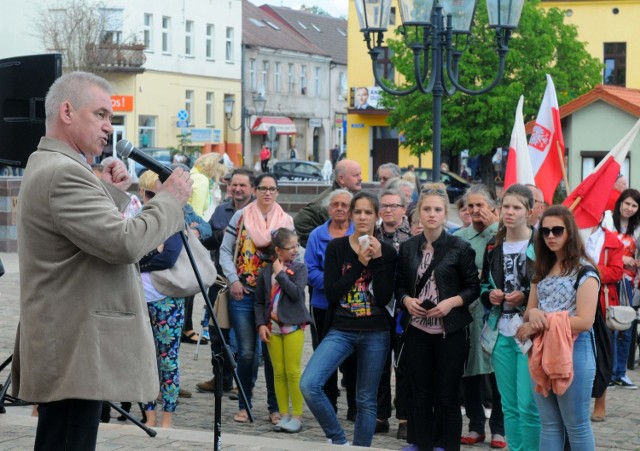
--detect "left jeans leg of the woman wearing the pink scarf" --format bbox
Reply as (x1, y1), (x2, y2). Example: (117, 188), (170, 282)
(229, 293), (257, 410)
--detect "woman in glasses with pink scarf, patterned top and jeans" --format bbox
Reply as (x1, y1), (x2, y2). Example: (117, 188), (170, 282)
(220, 174), (293, 425)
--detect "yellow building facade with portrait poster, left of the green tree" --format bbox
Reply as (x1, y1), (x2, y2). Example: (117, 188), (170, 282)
(346, 0), (422, 180)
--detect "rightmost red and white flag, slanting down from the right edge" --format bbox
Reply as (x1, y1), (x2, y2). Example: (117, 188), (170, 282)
(562, 120), (640, 229)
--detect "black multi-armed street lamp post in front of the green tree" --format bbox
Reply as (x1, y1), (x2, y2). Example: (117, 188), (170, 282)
(356, 0), (524, 181)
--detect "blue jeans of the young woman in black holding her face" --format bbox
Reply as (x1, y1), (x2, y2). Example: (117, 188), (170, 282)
(300, 329), (389, 446)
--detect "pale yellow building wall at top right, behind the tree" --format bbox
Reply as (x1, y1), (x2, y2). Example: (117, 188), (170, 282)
(541, 0), (640, 88)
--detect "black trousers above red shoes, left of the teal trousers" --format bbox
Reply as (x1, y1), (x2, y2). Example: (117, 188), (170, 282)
(462, 373), (504, 435)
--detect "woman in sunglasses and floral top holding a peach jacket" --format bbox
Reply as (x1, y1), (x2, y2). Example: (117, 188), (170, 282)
(516, 205), (600, 451)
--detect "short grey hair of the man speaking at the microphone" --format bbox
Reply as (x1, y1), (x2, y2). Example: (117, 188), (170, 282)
(44, 71), (112, 125)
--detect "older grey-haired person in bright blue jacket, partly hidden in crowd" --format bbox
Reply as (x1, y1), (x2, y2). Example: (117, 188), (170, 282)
(304, 189), (353, 408)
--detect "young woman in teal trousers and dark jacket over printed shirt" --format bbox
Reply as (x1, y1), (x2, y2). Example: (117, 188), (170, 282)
(480, 184), (540, 451)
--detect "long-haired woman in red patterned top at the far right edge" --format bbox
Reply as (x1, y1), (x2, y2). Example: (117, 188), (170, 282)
(610, 188), (640, 390)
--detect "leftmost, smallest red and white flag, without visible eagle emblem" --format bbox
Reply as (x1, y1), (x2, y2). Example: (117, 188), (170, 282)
(504, 96), (535, 190)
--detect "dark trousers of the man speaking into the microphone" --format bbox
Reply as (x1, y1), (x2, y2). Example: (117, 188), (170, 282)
(33, 399), (102, 451)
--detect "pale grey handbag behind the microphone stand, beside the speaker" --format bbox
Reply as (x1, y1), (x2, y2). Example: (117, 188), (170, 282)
(150, 228), (218, 298)
